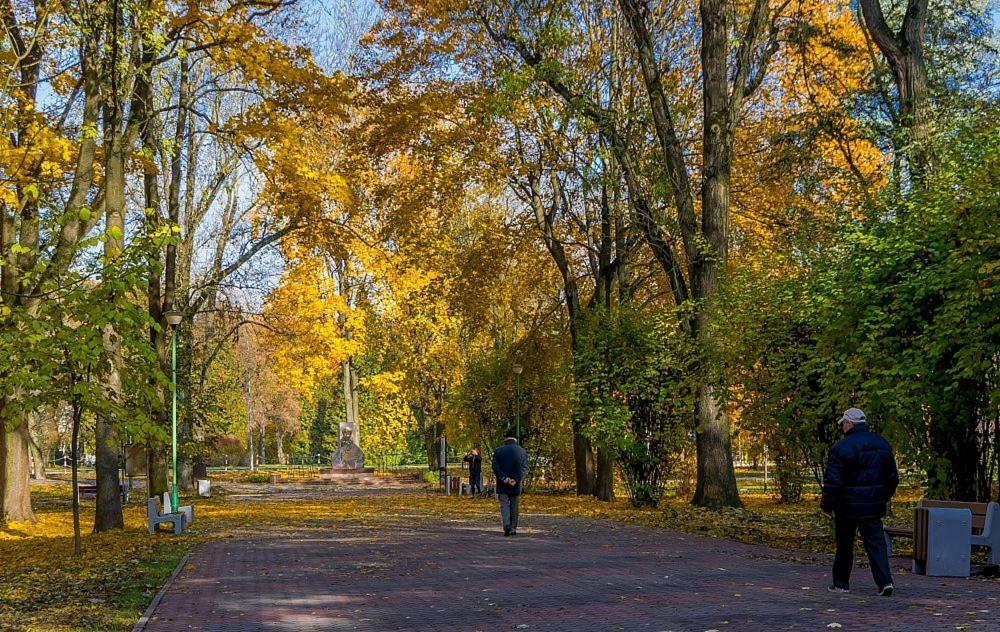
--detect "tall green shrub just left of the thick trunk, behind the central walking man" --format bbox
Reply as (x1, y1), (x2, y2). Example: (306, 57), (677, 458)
(576, 307), (696, 506)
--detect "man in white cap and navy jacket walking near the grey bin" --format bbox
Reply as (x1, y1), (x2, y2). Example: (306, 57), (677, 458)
(820, 408), (899, 597)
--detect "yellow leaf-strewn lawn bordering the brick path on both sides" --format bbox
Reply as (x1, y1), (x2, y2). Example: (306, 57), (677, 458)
(0, 485), (919, 632)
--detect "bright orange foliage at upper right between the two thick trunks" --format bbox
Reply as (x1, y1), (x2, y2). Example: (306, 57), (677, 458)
(733, 0), (889, 258)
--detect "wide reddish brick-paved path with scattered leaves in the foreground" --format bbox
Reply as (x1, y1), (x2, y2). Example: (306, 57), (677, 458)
(146, 500), (1000, 632)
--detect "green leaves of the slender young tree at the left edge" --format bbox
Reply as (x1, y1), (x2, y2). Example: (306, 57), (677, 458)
(0, 246), (166, 438)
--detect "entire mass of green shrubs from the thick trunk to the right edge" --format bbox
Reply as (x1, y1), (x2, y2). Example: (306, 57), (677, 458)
(726, 113), (1000, 500)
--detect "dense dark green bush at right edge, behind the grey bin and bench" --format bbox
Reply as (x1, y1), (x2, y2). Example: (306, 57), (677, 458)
(838, 112), (1000, 500)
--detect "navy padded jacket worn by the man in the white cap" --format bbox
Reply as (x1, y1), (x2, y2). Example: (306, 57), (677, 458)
(820, 424), (899, 520)
